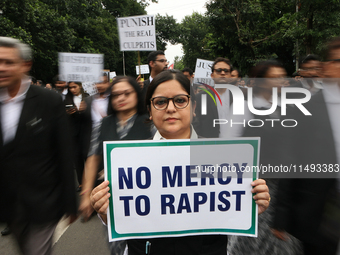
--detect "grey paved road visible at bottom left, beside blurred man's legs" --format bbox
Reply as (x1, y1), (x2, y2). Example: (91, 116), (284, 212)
(0, 216), (110, 255)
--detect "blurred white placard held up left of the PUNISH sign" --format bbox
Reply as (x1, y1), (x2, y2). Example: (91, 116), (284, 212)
(58, 52), (104, 83)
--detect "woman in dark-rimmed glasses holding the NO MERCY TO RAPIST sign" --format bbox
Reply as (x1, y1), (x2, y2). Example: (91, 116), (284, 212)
(91, 70), (270, 255)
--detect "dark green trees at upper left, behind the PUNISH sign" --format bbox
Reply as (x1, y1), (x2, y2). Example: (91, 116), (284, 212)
(0, 0), (162, 82)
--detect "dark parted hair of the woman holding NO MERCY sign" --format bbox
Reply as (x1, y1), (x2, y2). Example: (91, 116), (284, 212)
(145, 69), (196, 109)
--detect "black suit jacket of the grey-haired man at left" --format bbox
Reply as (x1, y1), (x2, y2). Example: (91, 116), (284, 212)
(0, 86), (77, 223)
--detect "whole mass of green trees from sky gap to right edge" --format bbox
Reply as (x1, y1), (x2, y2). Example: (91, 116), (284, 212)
(206, 0), (340, 74)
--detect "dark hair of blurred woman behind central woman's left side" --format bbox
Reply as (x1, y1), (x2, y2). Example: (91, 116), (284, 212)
(108, 76), (144, 114)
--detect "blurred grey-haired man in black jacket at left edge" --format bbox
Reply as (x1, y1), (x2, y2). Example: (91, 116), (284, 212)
(0, 37), (77, 254)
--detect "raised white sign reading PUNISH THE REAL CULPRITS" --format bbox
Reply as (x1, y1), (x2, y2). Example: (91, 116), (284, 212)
(117, 15), (157, 51)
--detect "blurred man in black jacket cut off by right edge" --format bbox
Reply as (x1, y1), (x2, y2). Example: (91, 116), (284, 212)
(273, 38), (340, 255)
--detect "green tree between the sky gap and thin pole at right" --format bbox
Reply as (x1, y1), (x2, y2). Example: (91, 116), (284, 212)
(207, 0), (293, 73)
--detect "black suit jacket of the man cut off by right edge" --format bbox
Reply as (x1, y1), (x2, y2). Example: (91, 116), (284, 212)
(273, 93), (339, 245)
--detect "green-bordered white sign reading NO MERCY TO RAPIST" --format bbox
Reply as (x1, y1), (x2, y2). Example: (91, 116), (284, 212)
(104, 138), (259, 241)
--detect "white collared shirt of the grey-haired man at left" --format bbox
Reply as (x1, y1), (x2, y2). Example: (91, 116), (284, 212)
(0, 77), (31, 144)
